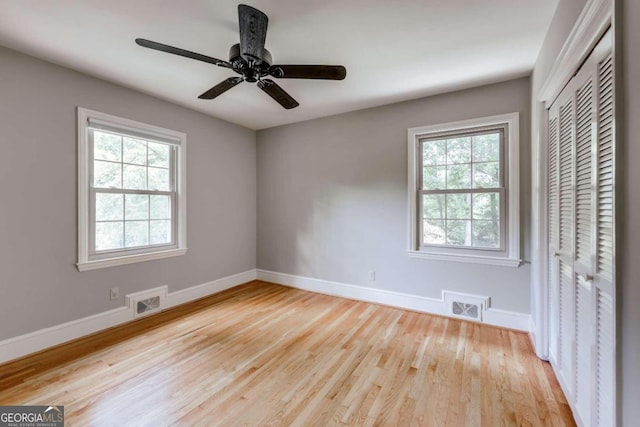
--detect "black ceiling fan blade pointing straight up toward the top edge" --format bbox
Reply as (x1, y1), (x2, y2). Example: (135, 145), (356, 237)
(238, 4), (269, 64)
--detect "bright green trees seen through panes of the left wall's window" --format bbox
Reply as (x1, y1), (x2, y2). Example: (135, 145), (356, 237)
(91, 130), (174, 252)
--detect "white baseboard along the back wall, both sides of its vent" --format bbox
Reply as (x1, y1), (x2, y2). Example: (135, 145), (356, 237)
(257, 270), (531, 332)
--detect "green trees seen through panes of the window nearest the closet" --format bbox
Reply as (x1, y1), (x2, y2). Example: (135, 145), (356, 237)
(419, 129), (504, 249)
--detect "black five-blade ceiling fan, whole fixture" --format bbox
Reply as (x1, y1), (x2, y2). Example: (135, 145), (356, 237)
(136, 4), (347, 110)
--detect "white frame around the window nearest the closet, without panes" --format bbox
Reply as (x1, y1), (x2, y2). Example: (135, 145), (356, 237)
(407, 112), (521, 267)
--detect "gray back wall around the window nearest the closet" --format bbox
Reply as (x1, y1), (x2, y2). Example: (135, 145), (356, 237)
(258, 78), (531, 313)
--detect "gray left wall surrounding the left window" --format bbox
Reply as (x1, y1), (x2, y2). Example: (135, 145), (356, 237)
(0, 47), (256, 339)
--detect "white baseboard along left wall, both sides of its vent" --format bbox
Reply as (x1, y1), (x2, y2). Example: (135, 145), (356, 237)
(0, 270), (256, 363)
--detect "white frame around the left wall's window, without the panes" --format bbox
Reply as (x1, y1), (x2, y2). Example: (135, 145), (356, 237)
(76, 107), (187, 271)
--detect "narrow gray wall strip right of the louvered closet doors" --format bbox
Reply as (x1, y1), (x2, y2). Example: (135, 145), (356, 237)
(616, 0), (640, 426)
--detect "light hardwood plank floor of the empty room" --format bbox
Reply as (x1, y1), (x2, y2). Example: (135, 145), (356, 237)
(0, 282), (575, 426)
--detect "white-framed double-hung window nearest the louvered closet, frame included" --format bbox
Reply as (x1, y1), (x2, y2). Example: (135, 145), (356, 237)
(408, 113), (520, 266)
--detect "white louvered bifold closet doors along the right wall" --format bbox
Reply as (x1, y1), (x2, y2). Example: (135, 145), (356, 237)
(548, 28), (615, 426)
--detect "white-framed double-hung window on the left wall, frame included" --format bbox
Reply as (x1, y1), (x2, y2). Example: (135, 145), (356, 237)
(77, 108), (186, 271)
